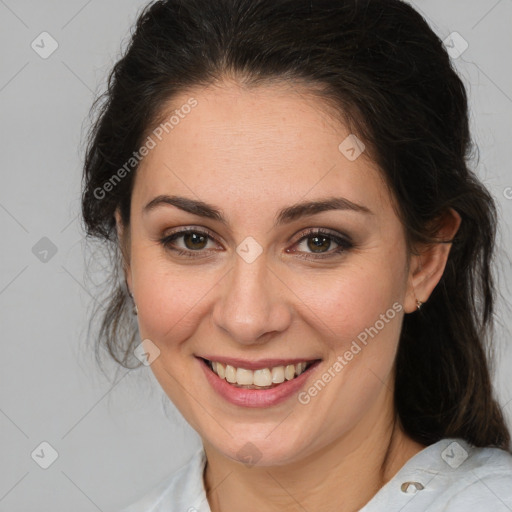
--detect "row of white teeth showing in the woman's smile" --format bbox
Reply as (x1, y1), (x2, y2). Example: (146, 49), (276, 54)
(201, 358), (320, 389)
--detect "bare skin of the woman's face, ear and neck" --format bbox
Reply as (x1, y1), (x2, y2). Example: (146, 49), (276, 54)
(116, 81), (460, 512)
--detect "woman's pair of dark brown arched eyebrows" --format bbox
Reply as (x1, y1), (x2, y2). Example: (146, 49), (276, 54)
(143, 195), (374, 227)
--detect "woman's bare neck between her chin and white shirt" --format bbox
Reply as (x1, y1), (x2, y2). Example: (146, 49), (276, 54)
(203, 386), (425, 512)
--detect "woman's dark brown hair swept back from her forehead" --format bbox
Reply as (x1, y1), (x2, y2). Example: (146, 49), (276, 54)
(82, 0), (510, 449)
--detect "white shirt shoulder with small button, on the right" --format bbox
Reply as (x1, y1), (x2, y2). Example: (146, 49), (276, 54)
(361, 438), (512, 512)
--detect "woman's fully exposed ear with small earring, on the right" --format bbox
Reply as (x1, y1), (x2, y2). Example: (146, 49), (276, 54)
(404, 208), (462, 313)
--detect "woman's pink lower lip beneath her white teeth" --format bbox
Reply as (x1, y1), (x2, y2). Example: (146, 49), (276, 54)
(197, 358), (320, 407)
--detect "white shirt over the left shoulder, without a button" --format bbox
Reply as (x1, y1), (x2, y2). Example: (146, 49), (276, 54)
(120, 447), (208, 512)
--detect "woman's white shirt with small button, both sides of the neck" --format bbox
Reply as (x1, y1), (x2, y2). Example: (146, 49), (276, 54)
(121, 438), (512, 512)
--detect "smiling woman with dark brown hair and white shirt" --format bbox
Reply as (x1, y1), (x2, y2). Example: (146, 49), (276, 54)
(83, 0), (512, 512)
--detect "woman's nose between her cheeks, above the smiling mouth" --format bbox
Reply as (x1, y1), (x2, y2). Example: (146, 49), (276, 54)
(212, 254), (292, 345)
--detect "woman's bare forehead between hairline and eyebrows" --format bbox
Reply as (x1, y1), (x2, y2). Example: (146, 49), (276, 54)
(133, 84), (390, 220)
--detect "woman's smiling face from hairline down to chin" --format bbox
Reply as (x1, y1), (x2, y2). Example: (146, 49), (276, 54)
(118, 84), (422, 465)
